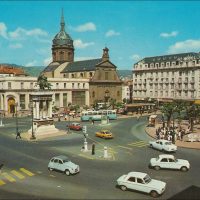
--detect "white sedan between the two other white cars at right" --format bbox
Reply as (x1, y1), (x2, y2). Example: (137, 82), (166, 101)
(149, 154), (190, 171)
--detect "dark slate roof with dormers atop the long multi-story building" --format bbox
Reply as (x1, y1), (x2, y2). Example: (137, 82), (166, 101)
(135, 52), (200, 64)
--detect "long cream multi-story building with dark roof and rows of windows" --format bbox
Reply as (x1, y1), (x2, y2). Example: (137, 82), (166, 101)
(133, 52), (200, 101)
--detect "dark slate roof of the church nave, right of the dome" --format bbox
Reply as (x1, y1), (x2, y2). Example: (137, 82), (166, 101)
(61, 58), (102, 73)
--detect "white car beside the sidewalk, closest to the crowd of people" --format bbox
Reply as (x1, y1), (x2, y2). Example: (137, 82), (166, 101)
(149, 140), (177, 152)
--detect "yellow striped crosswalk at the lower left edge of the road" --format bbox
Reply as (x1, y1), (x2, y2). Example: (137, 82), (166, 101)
(0, 168), (35, 186)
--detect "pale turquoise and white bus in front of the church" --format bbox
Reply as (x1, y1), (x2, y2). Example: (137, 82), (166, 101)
(81, 110), (117, 121)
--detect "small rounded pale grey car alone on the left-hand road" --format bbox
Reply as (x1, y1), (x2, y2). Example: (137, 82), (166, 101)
(48, 155), (80, 176)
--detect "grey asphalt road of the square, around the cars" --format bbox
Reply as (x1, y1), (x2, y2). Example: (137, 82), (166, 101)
(0, 118), (200, 199)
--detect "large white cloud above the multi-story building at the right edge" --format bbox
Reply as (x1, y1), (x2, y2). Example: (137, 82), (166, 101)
(167, 39), (200, 53)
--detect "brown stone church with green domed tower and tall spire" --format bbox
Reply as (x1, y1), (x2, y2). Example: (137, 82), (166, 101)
(42, 10), (122, 105)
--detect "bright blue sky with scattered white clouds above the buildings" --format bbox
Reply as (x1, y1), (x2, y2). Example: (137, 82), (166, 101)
(0, 1), (200, 70)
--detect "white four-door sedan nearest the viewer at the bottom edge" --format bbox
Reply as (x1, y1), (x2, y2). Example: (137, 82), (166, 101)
(117, 172), (166, 197)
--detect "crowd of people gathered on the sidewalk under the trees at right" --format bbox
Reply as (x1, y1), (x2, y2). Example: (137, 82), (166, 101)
(156, 126), (189, 144)
